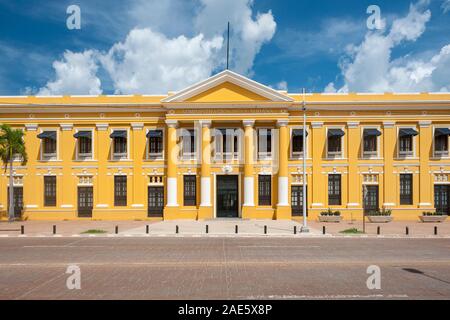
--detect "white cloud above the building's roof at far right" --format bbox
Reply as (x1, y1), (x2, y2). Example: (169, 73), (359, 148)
(325, 1), (450, 92)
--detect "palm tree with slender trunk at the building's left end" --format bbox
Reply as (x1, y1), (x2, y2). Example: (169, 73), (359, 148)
(0, 124), (28, 221)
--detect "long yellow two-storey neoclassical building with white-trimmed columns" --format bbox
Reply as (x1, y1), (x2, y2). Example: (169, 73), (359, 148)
(0, 71), (450, 220)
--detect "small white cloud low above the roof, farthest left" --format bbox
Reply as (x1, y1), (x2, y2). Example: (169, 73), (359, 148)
(38, 50), (102, 95)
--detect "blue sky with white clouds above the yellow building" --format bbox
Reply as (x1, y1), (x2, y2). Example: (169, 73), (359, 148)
(0, 0), (450, 95)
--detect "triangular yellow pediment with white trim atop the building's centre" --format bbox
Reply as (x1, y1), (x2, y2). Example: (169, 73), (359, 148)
(162, 70), (293, 103)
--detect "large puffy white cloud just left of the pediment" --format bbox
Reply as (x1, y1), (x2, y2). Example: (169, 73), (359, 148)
(100, 28), (223, 94)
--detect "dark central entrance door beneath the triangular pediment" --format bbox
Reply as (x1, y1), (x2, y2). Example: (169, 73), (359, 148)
(216, 175), (239, 218)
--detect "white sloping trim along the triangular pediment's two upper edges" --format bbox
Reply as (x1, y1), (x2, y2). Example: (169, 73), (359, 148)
(161, 70), (294, 103)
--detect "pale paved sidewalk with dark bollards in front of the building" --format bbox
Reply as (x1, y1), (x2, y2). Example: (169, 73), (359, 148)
(0, 219), (450, 238)
